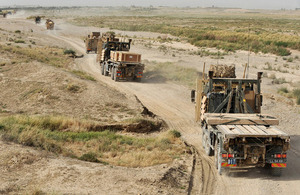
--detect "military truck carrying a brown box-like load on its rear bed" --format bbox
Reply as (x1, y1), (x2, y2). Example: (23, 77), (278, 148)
(97, 33), (144, 82)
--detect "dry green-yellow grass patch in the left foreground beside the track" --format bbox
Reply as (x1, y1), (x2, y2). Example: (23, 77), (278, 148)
(0, 115), (185, 167)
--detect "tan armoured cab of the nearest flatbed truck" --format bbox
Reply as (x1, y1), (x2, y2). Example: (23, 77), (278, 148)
(205, 71), (262, 113)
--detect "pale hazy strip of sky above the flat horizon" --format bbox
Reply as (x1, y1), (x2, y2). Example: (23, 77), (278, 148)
(0, 0), (300, 9)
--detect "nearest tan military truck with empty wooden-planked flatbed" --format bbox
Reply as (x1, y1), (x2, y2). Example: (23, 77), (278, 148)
(191, 65), (290, 176)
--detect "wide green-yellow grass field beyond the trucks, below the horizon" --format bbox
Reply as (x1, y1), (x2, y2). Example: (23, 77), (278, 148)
(73, 13), (300, 56)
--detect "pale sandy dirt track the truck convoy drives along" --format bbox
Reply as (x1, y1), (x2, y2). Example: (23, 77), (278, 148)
(2, 14), (300, 194)
